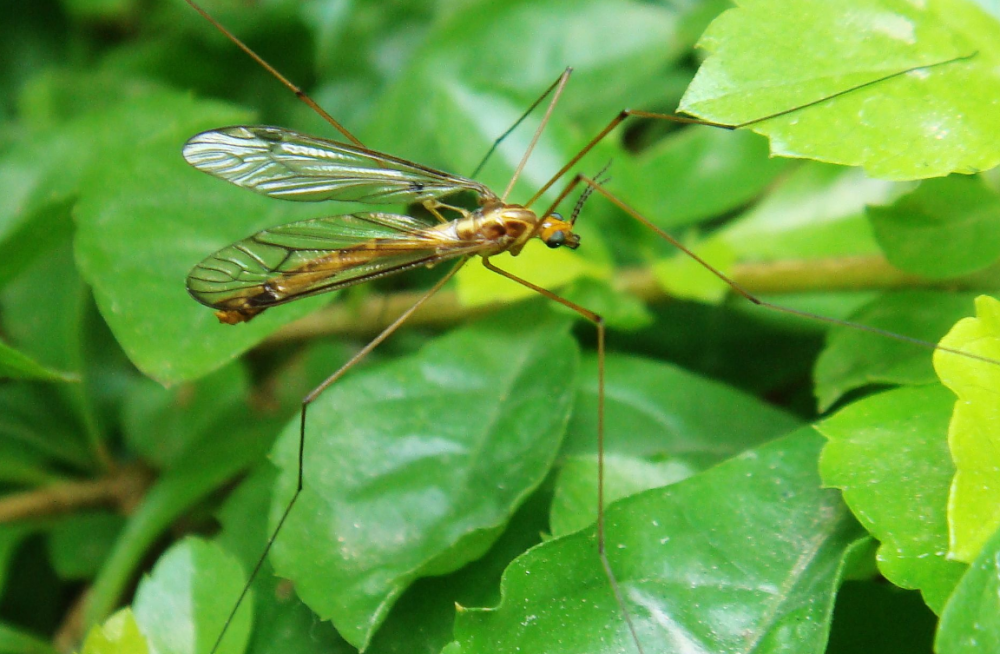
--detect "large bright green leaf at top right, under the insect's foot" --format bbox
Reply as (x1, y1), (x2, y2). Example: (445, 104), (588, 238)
(681, 0), (1000, 179)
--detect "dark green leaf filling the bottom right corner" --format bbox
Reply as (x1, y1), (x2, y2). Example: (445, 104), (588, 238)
(934, 532), (1000, 654)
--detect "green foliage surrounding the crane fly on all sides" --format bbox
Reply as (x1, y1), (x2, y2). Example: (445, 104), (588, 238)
(0, 0), (1000, 652)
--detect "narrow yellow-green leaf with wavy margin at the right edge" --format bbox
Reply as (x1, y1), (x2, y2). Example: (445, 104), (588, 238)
(934, 296), (1000, 563)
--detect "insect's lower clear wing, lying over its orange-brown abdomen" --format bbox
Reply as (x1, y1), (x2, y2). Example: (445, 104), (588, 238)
(187, 213), (483, 323)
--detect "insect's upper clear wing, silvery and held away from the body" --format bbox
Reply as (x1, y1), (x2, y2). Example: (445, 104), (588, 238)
(183, 126), (495, 204)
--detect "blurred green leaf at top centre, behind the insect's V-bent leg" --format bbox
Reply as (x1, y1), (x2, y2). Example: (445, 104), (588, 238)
(366, 0), (685, 182)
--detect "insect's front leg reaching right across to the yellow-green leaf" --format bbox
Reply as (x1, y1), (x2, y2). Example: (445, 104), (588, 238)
(542, 175), (1000, 365)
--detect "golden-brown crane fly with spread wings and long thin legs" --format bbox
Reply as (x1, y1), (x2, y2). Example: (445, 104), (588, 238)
(168, 1), (996, 650)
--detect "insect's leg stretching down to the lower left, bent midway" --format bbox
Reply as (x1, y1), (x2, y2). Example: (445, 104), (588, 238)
(211, 257), (468, 654)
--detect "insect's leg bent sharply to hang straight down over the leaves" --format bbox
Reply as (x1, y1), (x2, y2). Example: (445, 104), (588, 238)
(483, 258), (645, 654)
